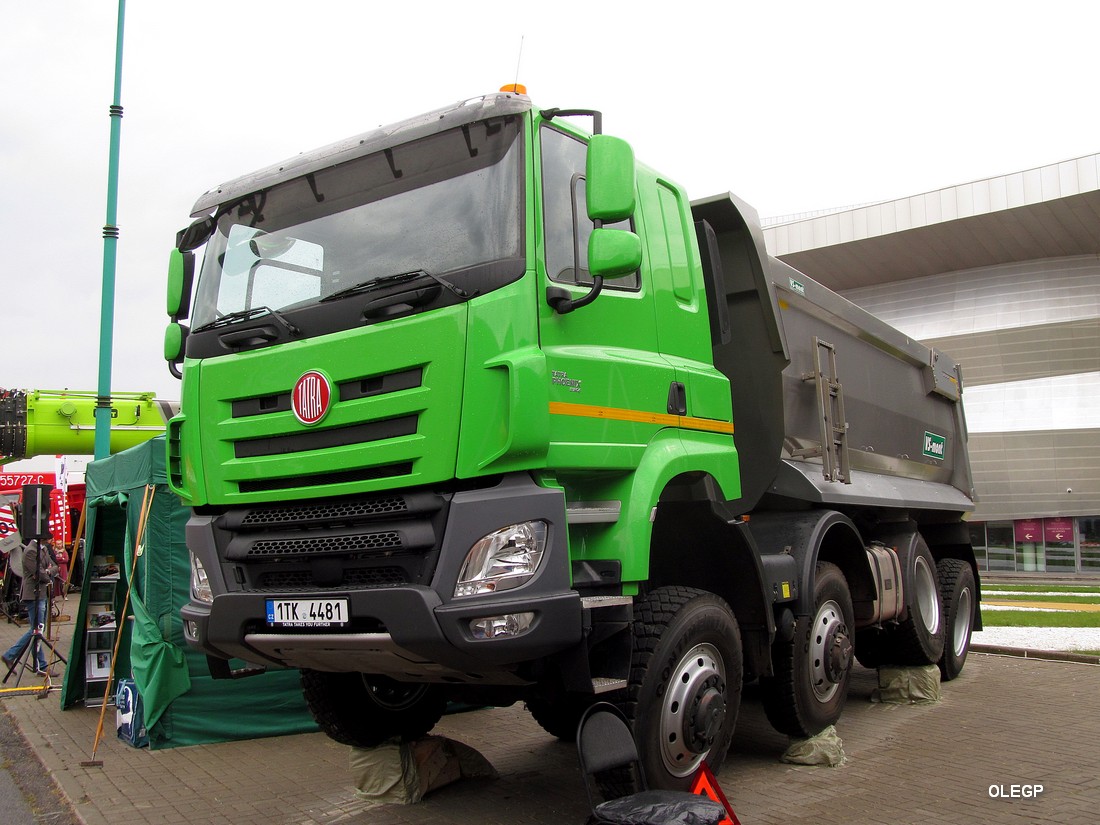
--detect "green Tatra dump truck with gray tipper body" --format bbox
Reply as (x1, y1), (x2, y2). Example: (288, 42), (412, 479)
(165, 89), (980, 788)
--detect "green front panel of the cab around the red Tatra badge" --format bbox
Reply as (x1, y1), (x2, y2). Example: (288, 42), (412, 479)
(169, 304), (468, 505)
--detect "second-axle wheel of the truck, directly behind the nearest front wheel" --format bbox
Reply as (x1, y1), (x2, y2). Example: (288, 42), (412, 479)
(760, 562), (855, 738)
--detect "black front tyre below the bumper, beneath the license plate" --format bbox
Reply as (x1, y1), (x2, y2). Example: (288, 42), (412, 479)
(301, 670), (447, 748)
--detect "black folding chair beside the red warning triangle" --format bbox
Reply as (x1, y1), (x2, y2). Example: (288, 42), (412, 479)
(576, 702), (726, 825)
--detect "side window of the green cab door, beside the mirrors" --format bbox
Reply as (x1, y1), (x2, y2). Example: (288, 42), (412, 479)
(541, 125), (639, 289)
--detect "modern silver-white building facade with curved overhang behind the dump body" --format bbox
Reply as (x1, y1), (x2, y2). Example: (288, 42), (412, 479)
(765, 154), (1100, 575)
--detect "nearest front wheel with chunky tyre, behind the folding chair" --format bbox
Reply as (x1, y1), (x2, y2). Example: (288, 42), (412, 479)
(625, 586), (743, 790)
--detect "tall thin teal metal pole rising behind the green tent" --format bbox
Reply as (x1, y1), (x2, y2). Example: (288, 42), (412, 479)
(95, 0), (127, 459)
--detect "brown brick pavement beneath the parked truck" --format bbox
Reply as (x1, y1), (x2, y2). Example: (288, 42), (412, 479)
(0, 623), (1100, 825)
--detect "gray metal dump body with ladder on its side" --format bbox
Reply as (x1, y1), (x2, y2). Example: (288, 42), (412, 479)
(693, 195), (974, 520)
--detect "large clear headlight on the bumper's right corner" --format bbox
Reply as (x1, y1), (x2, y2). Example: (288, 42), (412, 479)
(454, 521), (547, 596)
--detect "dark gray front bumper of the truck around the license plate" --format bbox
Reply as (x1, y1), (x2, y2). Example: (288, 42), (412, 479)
(182, 474), (583, 684)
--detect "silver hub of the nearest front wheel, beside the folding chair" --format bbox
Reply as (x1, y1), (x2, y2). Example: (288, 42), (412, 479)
(661, 645), (726, 777)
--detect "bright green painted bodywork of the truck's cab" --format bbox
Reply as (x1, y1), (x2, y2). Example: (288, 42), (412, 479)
(166, 100), (740, 592)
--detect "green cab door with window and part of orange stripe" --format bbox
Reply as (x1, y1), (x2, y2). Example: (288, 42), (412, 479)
(538, 123), (675, 472)
